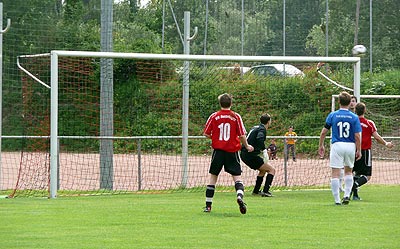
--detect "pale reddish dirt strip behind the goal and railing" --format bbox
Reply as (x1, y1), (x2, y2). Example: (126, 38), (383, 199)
(0, 152), (400, 191)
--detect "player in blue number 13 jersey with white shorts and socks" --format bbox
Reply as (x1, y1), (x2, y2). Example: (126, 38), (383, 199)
(318, 92), (361, 205)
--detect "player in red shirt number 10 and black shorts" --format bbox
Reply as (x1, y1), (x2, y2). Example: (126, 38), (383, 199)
(204, 93), (254, 214)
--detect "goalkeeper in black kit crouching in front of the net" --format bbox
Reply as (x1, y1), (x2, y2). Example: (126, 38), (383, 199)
(240, 114), (275, 197)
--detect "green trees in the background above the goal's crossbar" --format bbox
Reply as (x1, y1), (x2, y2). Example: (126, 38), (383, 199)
(3, 0), (400, 69)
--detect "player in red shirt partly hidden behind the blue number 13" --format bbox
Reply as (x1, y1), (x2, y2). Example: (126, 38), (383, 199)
(352, 102), (394, 200)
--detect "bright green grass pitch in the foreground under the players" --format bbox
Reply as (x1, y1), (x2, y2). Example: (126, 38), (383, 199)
(0, 185), (400, 249)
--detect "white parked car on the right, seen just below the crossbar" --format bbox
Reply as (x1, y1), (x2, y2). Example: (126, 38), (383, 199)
(247, 63), (305, 77)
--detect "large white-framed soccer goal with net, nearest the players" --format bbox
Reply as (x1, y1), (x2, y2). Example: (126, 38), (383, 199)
(4, 51), (366, 198)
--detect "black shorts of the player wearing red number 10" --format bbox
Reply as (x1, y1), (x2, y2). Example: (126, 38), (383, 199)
(208, 150), (242, 176)
